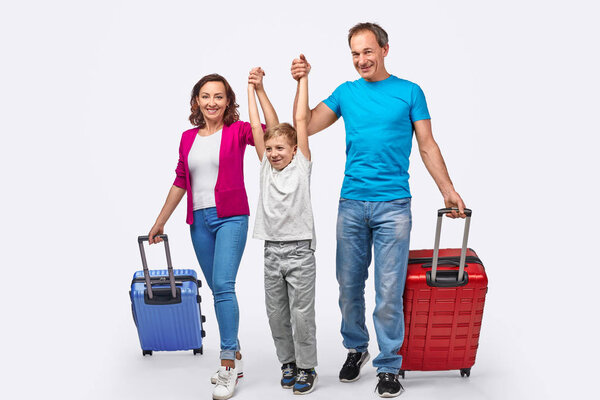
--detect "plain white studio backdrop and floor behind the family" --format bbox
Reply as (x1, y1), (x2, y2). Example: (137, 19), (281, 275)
(0, 0), (600, 399)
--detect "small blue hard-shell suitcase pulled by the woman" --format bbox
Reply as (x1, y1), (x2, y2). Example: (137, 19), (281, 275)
(129, 235), (205, 355)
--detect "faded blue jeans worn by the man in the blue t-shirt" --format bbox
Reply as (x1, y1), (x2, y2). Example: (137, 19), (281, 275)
(336, 198), (412, 374)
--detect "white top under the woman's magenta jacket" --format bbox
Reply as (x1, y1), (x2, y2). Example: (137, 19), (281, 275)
(188, 130), (222, 210)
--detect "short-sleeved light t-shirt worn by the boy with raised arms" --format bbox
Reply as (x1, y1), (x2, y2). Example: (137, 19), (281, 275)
(253, 149), (316, 250)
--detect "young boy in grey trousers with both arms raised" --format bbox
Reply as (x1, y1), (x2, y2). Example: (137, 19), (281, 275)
(248, 68), (317, 394)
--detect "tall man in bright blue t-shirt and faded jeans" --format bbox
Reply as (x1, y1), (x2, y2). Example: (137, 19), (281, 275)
(292, 23), (465, 397)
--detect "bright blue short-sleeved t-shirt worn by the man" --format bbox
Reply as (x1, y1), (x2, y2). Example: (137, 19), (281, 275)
(323, 75), (430, 201)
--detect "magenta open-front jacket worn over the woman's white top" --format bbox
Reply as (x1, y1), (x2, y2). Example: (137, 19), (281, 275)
(173, 121), (265, 225)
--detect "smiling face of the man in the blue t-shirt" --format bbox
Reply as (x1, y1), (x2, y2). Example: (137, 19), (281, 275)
(350, 30), (390, 82)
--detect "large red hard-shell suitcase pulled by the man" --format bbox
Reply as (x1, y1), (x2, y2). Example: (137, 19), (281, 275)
(399, 209), (488, 378)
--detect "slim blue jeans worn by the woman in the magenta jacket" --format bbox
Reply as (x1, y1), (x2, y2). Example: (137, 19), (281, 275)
(190, 207), (248, 360)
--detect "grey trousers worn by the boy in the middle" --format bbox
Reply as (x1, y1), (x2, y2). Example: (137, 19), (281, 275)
(265, 240), (317, 369)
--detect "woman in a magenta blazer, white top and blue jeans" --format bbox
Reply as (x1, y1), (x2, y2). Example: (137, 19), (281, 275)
(149, 69), (278, 399)
